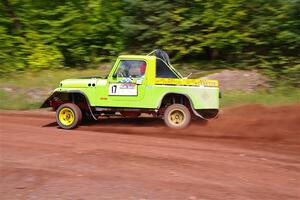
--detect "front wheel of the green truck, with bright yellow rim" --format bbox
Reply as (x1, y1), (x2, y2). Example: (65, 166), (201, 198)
(56, 103), (82, 129)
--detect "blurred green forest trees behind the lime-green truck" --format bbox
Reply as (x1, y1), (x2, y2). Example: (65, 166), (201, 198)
(0, 0), (300, 81)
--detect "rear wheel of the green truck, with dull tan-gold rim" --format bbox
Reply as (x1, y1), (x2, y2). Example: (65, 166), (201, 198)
(164, 104), (191, 129)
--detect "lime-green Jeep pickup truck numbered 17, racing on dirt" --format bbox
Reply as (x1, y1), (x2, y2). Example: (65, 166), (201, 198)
(41, 50), (219, 129)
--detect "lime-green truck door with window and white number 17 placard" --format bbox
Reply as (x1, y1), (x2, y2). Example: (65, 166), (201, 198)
(96, 60), (147, 107)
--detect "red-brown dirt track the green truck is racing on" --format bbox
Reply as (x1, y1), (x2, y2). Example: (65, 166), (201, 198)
(0, 104), (300, 200)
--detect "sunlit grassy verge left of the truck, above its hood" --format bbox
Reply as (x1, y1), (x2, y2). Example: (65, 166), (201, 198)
(0, 68), (111, 110)
